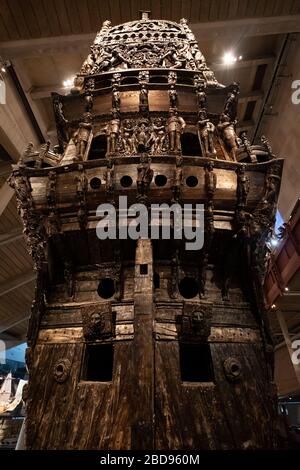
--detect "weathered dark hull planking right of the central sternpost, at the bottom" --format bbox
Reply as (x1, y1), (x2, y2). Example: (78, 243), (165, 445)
(155, 342), (276, 450)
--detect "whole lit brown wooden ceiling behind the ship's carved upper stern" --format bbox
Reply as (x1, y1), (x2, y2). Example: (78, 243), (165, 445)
(0, 0), (300, 149)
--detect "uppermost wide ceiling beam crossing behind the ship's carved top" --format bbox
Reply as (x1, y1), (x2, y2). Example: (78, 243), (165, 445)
(0, 15), (300, 59)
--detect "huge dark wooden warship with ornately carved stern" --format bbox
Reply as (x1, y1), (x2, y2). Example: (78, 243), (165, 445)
(10, 13), (283, 450)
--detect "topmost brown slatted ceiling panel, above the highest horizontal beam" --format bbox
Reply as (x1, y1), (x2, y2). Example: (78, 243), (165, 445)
(0, 0), (300, 41)
